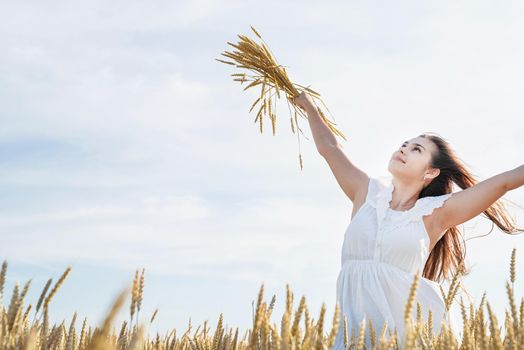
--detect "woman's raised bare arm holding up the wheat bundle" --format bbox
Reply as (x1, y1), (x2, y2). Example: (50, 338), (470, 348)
(295, 93), (369, 204)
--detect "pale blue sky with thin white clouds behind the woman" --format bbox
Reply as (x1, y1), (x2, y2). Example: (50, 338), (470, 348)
(0, 0), (524, 340)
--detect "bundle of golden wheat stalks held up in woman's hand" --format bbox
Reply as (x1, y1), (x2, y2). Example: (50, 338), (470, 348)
(216, 26), (346, 170)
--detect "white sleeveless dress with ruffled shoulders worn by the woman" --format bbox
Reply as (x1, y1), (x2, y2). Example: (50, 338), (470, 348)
(332, 177), (461, 350)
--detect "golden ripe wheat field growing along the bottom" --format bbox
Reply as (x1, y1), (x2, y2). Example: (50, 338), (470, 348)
(0, 248), (524, 350)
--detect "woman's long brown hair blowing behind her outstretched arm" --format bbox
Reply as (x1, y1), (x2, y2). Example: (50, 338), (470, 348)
(419, 133), (524, 282)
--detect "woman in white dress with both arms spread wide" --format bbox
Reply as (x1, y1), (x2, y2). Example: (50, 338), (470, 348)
(294, 93), (524, 350)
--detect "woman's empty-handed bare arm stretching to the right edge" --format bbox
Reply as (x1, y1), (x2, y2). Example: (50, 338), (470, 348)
(434, 165), (524, 231)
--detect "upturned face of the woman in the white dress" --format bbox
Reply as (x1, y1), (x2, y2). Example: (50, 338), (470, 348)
(388, 137), (438, 182)
